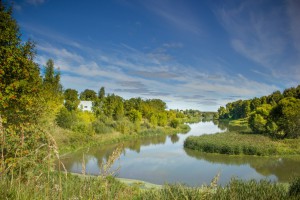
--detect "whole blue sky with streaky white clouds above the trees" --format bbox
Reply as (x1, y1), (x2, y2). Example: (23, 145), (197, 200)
(9, 0), (300, 111)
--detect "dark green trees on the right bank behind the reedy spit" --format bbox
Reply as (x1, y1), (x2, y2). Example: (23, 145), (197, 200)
(218, 85), (300, 138)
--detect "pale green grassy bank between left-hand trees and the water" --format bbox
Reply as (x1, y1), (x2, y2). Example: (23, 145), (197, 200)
(49, 124), (190, 154)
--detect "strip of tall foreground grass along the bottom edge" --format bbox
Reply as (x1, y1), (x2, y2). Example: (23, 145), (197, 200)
(0, 172), (300, 200)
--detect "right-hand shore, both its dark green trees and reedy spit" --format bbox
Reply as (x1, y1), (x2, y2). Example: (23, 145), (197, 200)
(184, 85), (300, 156)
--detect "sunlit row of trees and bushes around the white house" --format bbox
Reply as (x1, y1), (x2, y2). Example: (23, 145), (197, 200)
(56, 87), (200, 134)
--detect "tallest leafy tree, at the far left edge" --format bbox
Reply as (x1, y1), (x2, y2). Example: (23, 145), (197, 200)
(0, 1), (47, 174)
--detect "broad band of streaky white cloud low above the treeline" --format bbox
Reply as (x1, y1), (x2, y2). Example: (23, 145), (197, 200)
(30, 22), (278, 110)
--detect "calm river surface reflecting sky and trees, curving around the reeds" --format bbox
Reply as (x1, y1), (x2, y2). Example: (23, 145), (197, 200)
(63, 121), (300, 186)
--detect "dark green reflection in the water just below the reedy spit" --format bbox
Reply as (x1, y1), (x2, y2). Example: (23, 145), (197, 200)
(184, 148), (300, 182)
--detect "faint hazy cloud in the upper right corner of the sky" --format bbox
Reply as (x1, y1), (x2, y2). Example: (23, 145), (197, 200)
(216, 0), (300, 82)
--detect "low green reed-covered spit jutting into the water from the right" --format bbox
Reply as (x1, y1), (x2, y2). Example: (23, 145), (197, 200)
(184, 132), (300, 156)
